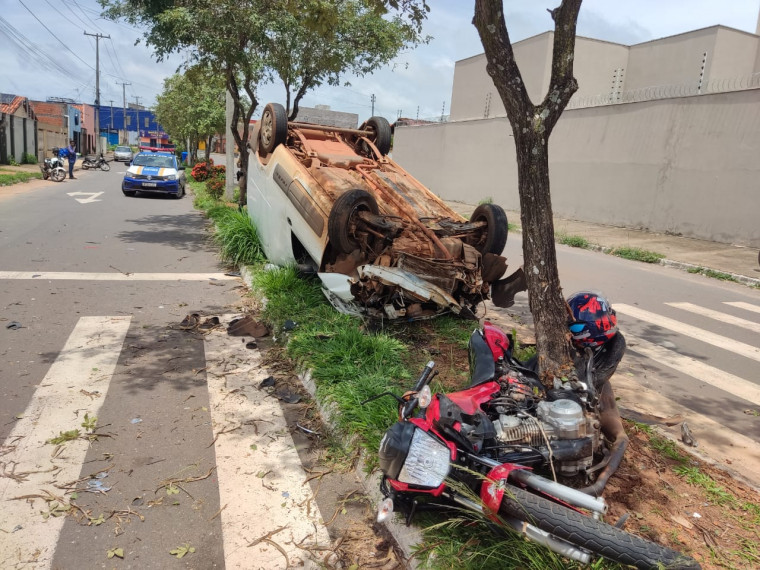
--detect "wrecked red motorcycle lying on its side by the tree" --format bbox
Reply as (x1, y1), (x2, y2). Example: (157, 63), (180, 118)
(368, 323), (700, 569)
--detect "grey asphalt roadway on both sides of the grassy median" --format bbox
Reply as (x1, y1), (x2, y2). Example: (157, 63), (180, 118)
(0, 171), (760, 568)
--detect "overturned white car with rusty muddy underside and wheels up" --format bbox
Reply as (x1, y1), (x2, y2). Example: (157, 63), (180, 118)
(247, 103), (524, 319)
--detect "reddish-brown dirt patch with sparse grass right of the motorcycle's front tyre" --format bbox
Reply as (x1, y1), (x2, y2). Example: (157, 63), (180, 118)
(604, 422), (760, 568)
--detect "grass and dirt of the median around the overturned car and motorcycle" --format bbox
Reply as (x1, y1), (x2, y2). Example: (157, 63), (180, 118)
(189, 177), (760, 570)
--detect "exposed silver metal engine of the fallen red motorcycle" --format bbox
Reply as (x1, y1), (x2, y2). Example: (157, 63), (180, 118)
(492, 373), (601, 476)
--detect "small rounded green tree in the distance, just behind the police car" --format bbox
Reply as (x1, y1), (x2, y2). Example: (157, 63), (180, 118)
(155, 67), (225, 164)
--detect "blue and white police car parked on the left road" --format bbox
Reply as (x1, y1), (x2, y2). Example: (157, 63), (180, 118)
(121, 151), (185, 198)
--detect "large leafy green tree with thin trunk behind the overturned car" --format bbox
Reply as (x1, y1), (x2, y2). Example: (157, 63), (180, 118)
(99, 0), (428, 204)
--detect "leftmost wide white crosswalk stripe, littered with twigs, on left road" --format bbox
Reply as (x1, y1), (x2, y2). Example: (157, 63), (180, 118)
(0, 316), (131, 570)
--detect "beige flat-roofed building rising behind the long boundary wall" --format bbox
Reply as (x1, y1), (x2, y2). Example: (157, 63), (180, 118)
(449, 26), (760, 121)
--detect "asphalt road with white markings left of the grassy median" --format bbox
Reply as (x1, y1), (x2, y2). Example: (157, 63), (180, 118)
(0, 169), (329, 568)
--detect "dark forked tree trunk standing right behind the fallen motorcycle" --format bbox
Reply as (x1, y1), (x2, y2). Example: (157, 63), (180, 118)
(473, 0), (581, 386)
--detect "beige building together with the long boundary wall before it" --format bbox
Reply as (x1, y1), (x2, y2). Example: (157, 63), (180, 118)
(393, 26), (760, 247)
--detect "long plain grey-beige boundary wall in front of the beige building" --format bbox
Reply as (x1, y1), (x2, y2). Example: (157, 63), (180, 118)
(393, 89), (760, 247)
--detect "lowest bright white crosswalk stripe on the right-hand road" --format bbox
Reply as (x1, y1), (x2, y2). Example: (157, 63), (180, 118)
(628, 330), (760, 406)
